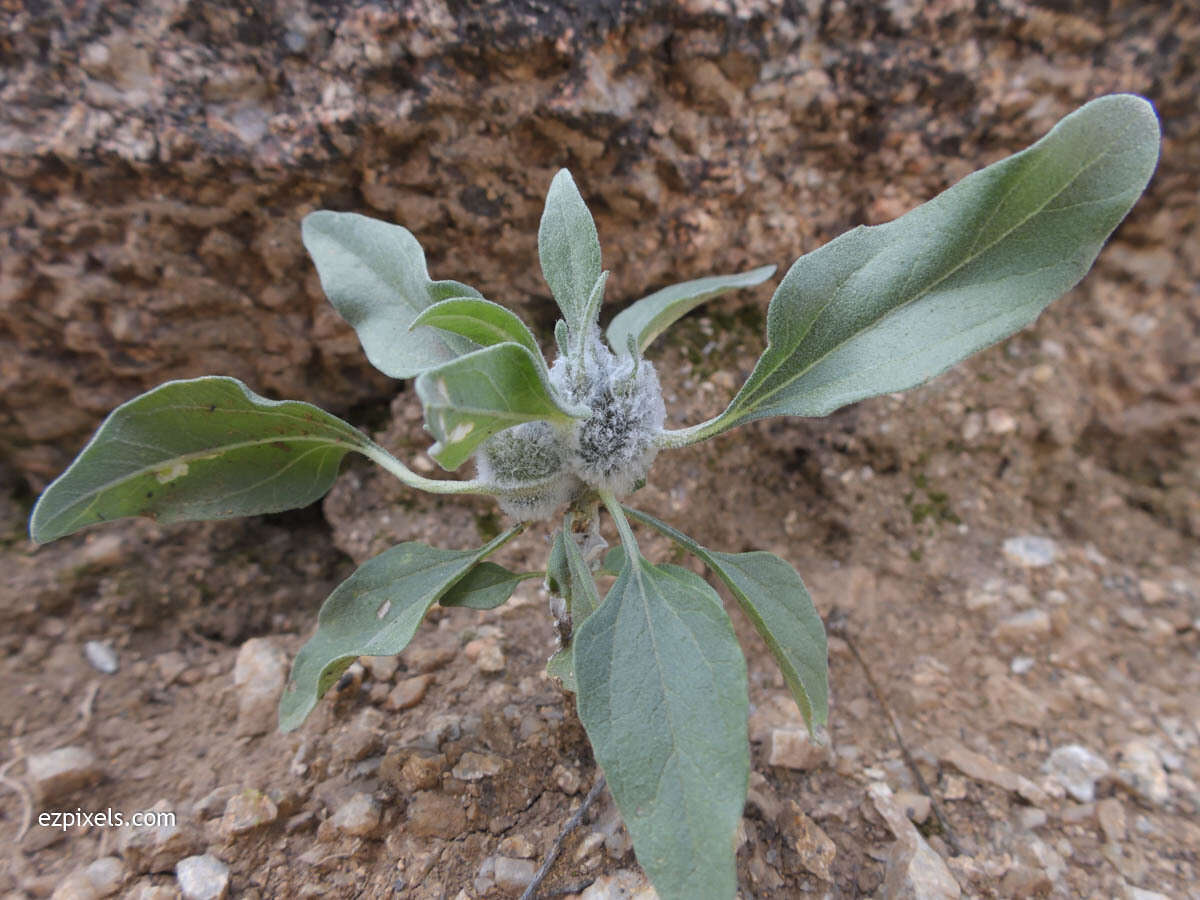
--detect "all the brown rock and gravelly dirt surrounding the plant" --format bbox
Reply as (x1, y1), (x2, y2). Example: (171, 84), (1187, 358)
(0, 0), (1200, 900)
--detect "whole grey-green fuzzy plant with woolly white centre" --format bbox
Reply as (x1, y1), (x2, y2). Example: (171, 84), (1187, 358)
(30, 95), (1159, 898)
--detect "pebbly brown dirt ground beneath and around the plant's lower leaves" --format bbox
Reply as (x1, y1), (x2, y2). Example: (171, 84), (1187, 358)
(0, 234), (1200, 900)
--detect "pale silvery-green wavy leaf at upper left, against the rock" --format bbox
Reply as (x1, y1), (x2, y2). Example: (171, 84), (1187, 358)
(301, 210), (479, 378)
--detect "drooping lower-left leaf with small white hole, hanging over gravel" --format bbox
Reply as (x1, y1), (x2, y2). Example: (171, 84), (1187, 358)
(280, 528), (520, 731)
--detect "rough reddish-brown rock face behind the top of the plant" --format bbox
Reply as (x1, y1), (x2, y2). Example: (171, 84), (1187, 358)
(0, 0), (1200, 487)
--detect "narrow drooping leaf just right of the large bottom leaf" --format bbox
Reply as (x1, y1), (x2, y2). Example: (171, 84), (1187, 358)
(625, 506), (829, 730)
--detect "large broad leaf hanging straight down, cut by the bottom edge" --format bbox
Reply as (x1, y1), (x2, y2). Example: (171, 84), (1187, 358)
(574, 557), (750, 900)
